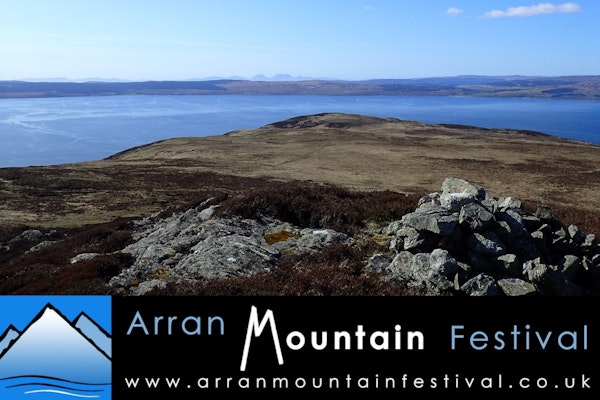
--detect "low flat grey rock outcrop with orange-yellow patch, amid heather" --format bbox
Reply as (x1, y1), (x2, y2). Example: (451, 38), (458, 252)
(106, 200), (352, 295)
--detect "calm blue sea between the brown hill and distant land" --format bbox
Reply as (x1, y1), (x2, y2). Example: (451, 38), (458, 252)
(0, 95), (600, 168)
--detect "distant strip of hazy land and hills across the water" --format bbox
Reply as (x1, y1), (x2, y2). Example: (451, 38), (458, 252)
(0, 75), (600, 100)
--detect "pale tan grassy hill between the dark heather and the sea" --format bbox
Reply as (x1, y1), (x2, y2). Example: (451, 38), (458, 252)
(104, 114), (600, 217)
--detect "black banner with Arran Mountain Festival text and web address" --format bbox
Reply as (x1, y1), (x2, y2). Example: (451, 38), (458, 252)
(112, 297), (599, 399)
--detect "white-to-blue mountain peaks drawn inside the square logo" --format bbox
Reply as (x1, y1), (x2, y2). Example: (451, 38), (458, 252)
(0, 304), (111, 383)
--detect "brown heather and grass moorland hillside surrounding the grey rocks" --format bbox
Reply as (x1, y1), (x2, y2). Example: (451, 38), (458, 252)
(0, 114), (600, 294)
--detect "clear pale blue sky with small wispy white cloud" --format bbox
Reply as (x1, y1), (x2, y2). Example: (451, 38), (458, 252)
(0, 0), (600, 80)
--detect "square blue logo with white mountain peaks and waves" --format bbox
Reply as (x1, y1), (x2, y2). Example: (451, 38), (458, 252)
(0, 296), (112, 400)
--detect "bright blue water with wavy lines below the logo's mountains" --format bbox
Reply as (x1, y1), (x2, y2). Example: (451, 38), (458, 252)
(0, 375), (111, 400)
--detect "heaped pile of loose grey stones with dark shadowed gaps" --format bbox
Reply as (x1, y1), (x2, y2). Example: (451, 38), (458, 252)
(368, 178), (600, 296)
